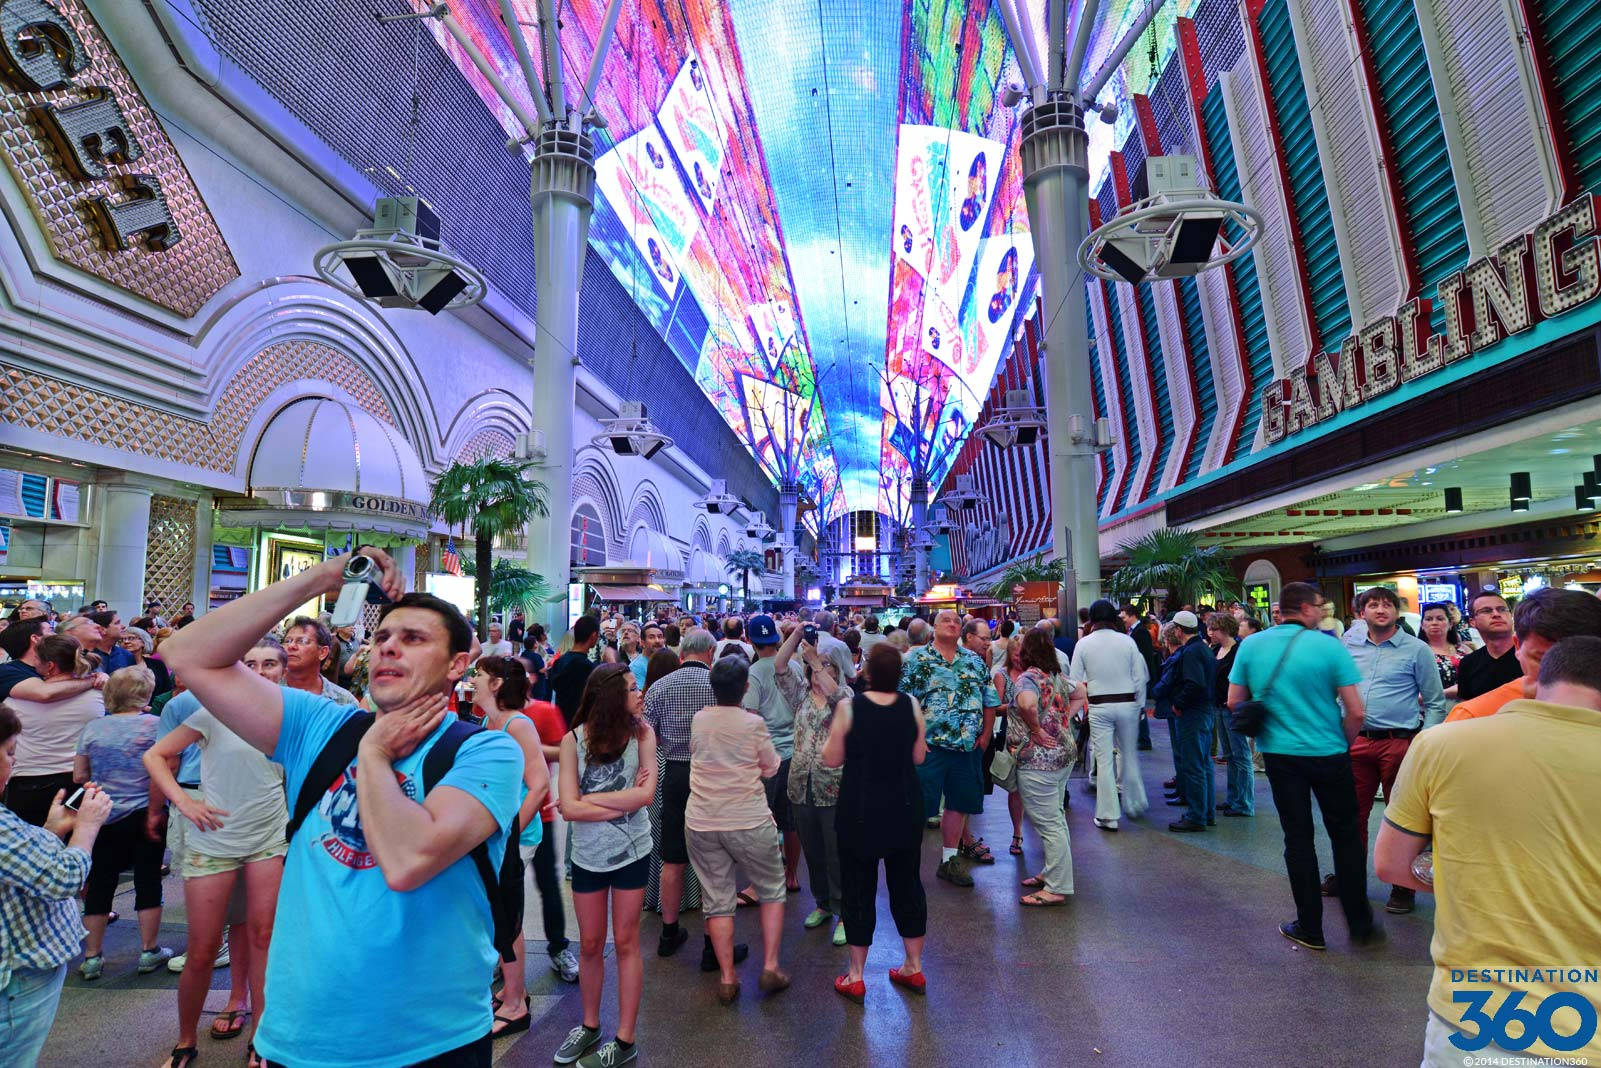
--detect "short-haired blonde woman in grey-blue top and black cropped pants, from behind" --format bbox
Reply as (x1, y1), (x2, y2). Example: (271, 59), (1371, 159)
(72, 666), (173, 980)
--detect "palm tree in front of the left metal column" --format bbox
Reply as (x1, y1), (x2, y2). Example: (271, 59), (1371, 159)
(427, 456), (551, 640)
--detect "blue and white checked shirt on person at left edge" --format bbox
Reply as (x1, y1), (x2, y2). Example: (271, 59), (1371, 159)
(0, 809), (90, 990)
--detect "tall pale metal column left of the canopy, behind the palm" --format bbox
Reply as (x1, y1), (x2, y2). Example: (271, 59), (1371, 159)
(528, 125), (596, 642)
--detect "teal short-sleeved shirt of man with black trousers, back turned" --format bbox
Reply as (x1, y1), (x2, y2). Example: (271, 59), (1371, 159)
(1228, 623), (1362, 756)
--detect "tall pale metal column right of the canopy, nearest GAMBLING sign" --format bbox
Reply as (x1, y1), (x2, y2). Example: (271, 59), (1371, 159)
(1021, 96), (1100, 624)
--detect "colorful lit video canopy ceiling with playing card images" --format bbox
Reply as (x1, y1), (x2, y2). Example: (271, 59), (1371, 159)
(413, 0), (1191, 519)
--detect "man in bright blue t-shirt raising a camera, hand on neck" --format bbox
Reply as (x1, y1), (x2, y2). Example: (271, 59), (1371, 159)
(162, 548), (522, 1068)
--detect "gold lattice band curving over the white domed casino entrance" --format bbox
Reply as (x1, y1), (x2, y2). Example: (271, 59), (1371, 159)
(0, 341), (395, 472)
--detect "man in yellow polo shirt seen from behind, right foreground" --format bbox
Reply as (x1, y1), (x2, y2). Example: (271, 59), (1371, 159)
(1374, 634), (1601, 1068)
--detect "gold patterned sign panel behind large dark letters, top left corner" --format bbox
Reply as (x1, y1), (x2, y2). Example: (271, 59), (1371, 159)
(0, 0), (239, 315)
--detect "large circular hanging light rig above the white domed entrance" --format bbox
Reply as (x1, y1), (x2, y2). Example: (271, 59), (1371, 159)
(312, 197), (487, 315)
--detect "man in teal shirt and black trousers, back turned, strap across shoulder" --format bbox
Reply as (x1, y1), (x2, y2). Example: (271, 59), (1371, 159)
(1228, 583), (1378, 950)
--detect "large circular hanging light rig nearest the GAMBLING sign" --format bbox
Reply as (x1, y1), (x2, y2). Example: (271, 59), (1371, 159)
(1079, 155), (1262, 285)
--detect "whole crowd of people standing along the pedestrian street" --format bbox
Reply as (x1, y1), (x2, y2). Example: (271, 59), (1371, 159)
(0, 560), (1601, 1068)
